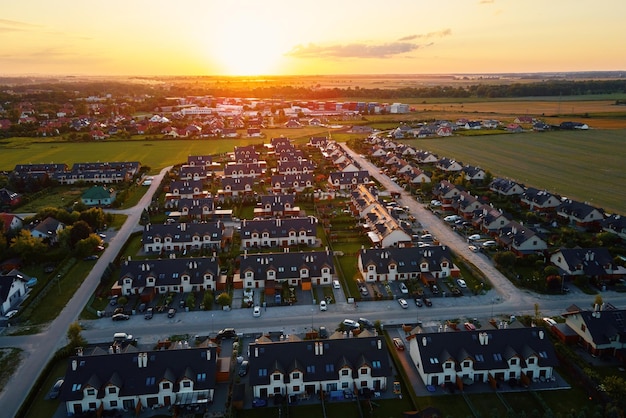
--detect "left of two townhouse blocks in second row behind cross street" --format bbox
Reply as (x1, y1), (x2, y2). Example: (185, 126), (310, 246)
(141, 221), (224, 254)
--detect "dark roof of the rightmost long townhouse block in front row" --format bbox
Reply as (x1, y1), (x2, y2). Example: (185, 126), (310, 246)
(416, 327), (558, 373)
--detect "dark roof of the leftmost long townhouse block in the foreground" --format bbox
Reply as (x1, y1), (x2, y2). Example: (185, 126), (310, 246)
(59, 347), (217, 402)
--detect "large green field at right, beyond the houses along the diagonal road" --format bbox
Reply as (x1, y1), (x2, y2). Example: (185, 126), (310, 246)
(403, 129), (626, 213)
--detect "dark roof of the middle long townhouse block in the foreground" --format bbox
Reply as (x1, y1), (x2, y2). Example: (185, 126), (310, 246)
(249, 337), (390, 386)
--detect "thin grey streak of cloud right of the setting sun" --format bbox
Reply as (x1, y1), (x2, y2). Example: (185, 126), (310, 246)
(286, 29), (452, 58)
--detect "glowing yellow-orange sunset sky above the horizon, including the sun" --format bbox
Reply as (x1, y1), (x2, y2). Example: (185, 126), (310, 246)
(0, 0), (626, 75)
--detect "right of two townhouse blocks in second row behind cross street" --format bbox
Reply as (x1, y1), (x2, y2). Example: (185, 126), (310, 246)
(241, 216), (318, 248)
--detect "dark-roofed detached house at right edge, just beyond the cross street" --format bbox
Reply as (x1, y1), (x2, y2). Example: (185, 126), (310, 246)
(550, 247), (626, 284)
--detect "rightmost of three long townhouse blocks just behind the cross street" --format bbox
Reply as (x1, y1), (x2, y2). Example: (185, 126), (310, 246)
(357, 246), (460, 282)
